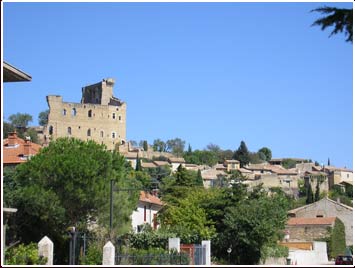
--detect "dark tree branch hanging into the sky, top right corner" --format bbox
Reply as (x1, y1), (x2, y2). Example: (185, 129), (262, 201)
(312, 6), (353, 43)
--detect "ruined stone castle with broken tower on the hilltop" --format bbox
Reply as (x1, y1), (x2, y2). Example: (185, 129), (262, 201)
(45, 78), (126, 150)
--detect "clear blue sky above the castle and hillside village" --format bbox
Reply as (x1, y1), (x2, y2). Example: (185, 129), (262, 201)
(3, 3), (353, 168)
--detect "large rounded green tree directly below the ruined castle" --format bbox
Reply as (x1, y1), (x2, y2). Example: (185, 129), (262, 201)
(6, 138), (139, 264)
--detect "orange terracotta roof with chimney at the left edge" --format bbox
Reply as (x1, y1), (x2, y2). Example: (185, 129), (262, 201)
(3, 132), (42, 164)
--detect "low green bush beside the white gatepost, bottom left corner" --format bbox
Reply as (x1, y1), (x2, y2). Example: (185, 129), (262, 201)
(5, 243), (47, 265)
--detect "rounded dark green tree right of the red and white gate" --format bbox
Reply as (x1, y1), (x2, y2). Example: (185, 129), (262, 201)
(214, 193), (288, 265)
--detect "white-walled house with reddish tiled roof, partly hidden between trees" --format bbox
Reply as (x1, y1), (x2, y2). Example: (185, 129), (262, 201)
(131, 191), (163, 232)
